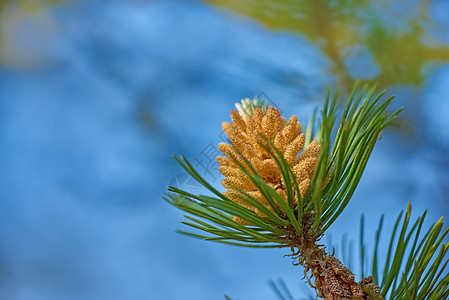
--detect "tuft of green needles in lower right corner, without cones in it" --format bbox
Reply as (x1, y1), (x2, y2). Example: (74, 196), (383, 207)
(360, 203), (449, 300)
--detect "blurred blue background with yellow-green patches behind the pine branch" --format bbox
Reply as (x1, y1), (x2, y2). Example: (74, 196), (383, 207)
(0, 0), (449, 300)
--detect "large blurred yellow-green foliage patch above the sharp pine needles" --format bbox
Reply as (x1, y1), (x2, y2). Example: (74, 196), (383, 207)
(206, 0), (449, 89)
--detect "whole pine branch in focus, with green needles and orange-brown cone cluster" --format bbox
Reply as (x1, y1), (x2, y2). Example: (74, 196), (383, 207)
(164, 82), (448, 299)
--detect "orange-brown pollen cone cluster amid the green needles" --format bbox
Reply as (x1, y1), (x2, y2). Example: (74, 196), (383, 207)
(217, 106), (320, 224)
